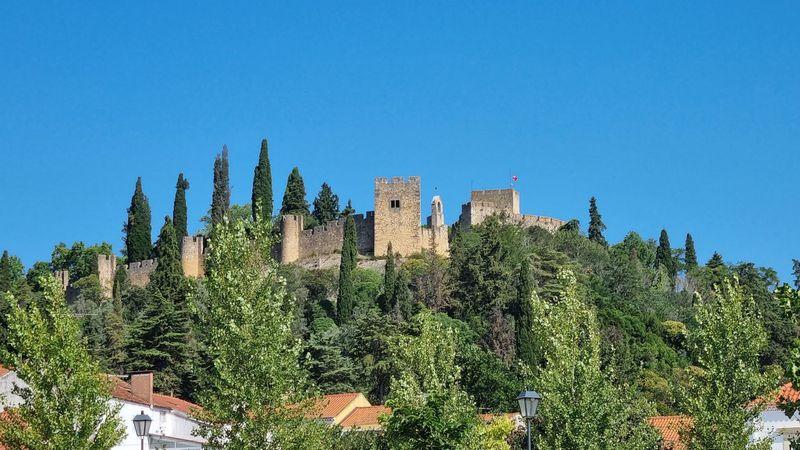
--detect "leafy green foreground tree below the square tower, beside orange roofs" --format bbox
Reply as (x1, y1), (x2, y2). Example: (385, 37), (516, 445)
(384, 311), (479, 449)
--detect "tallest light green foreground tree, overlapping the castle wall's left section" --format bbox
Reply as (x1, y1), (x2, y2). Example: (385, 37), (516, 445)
(198, 217), (327, 450)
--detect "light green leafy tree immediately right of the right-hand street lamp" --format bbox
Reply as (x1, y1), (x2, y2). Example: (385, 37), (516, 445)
(532, 270), (657, 449)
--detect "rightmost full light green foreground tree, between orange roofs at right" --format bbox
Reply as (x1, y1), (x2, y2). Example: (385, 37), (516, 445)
(683, 279), (778, 449)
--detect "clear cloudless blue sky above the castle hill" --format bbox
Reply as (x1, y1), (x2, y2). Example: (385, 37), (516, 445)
(0, 1), (800, 281)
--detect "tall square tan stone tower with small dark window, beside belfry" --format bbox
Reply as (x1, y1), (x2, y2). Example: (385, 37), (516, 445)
(375, 177), (422, 256)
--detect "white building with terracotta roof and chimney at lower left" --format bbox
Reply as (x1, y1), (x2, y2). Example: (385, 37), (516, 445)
(0, 366), (205, 450)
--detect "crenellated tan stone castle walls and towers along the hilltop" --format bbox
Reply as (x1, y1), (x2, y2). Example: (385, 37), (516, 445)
(84, 176), (566, 297)
